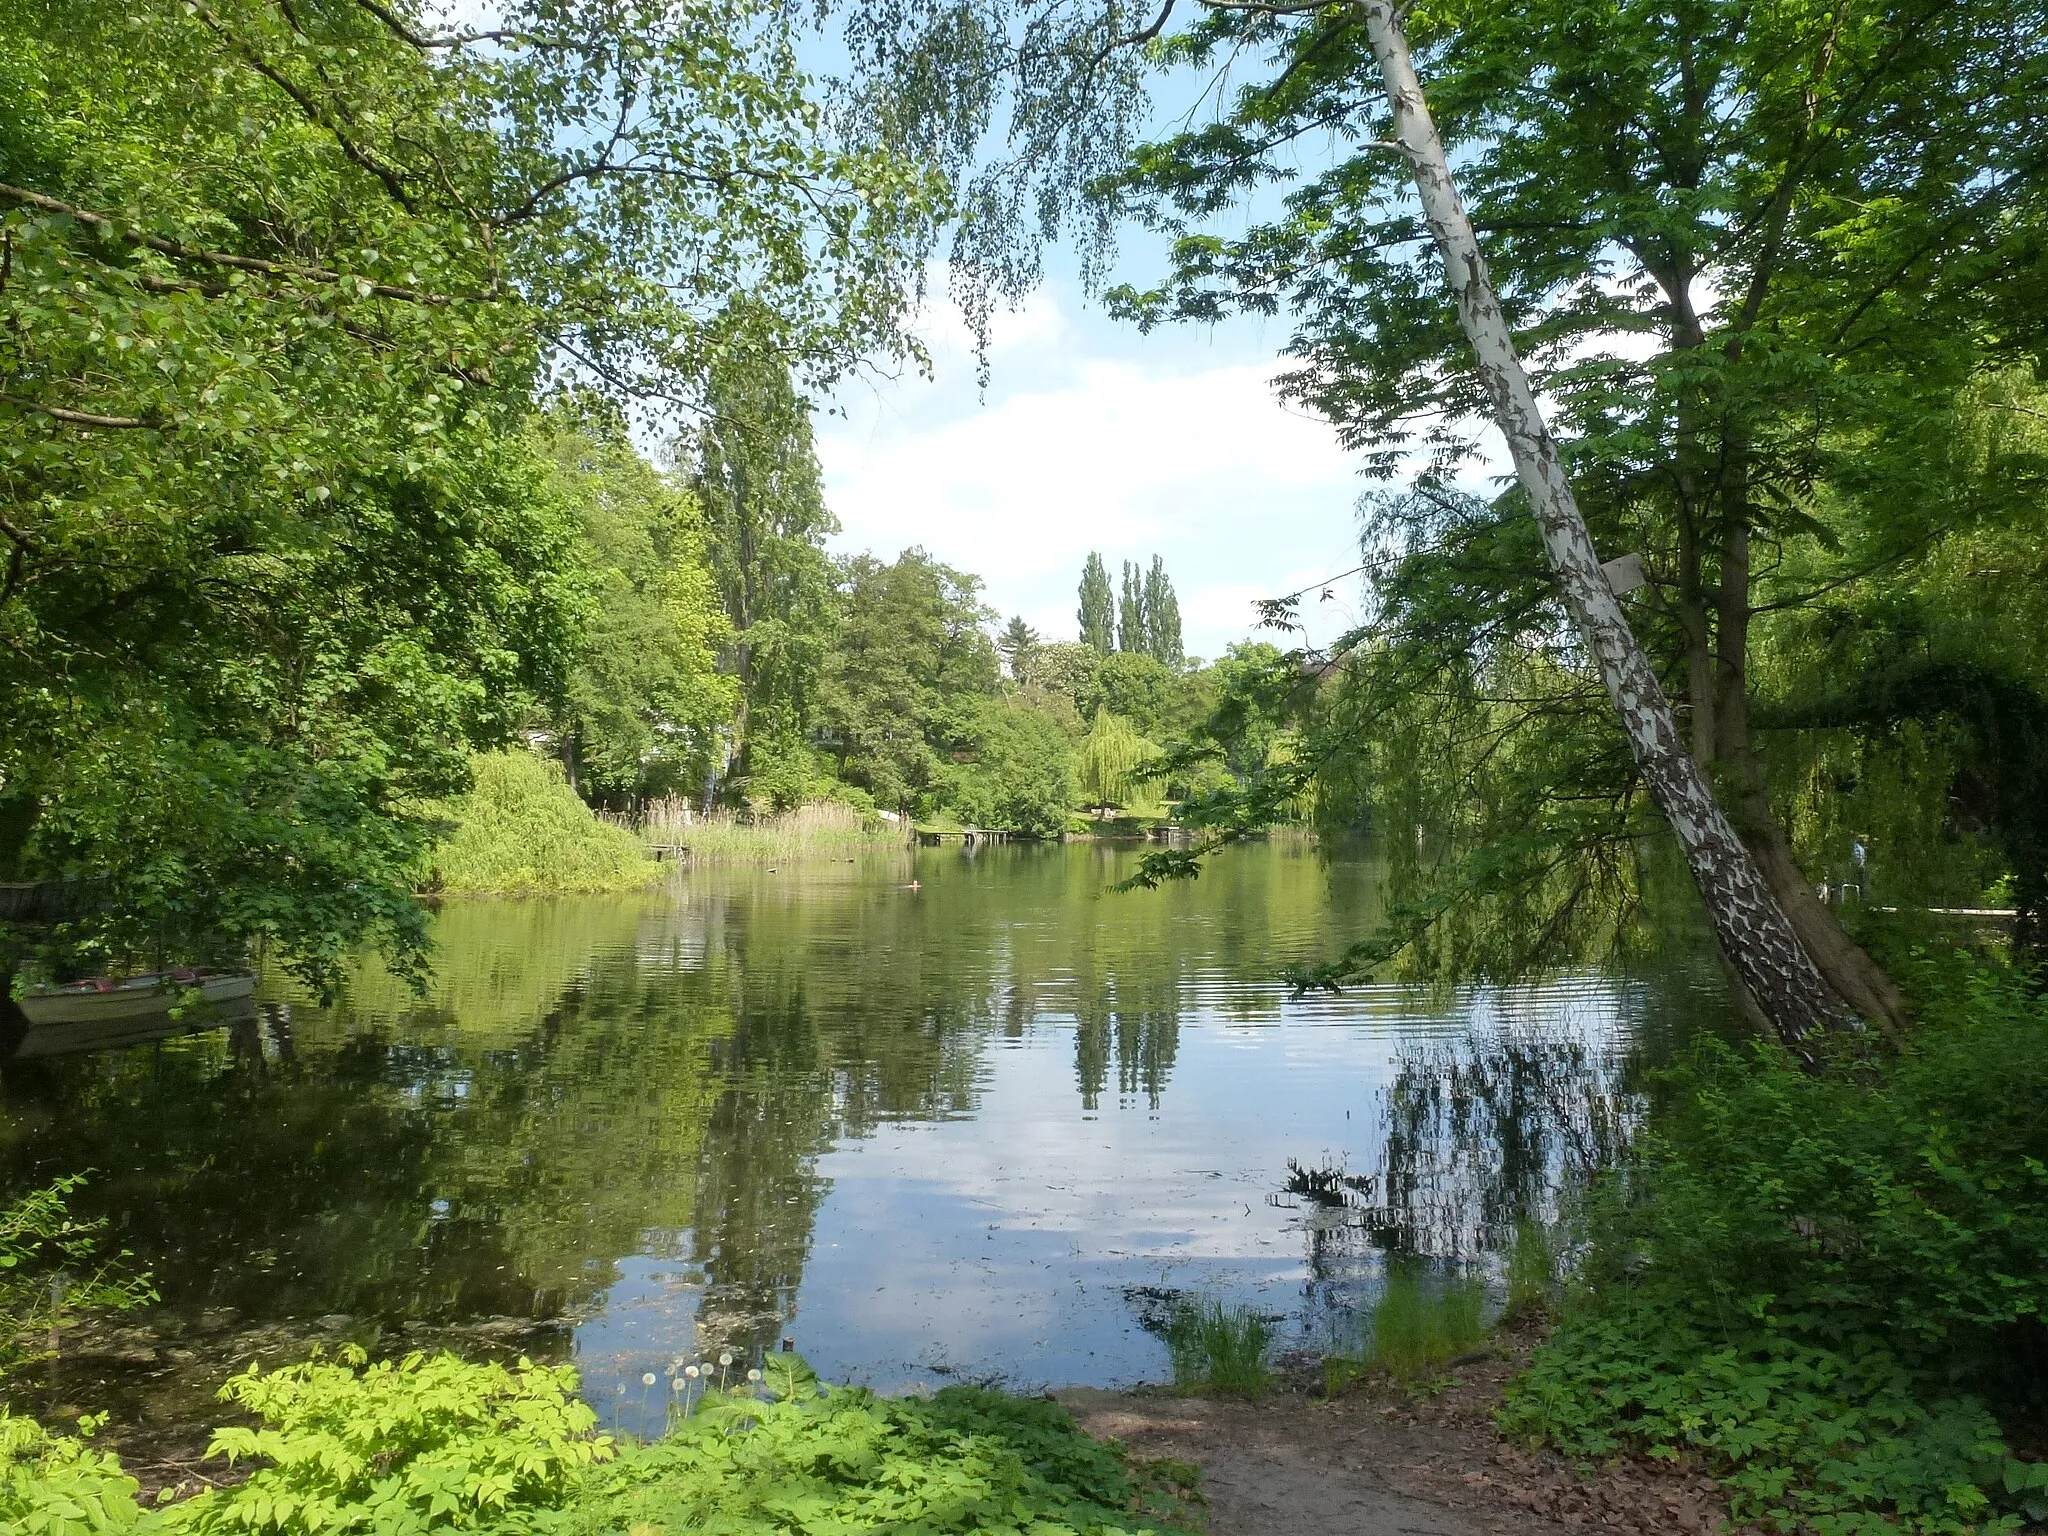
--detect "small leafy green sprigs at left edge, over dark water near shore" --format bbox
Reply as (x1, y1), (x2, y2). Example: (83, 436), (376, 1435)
(0, 1174), (156, 1378)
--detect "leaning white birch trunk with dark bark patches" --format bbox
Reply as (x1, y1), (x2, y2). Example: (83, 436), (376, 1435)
(1356, 0), (1853, 1063)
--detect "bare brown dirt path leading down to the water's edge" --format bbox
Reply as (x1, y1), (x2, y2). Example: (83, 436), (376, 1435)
(1057, 1350), (1724, 1536)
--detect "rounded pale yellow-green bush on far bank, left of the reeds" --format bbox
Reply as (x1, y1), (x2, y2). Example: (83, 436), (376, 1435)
(430, 748), (662, 895)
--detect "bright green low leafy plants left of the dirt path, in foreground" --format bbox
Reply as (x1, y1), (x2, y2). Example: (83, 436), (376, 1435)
(0, 1352), (1188, 1536)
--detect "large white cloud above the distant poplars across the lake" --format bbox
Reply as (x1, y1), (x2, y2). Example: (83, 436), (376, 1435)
(819, 297), (1360, 655)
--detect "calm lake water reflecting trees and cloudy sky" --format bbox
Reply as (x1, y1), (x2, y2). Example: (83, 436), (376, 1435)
(0, 842), (1726, 1427)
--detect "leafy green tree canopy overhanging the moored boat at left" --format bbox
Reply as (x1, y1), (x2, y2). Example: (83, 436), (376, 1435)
(0, 0), (938, 983)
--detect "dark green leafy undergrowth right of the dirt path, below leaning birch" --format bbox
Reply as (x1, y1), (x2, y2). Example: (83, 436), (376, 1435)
(1501, 954), (2048, 1536)
